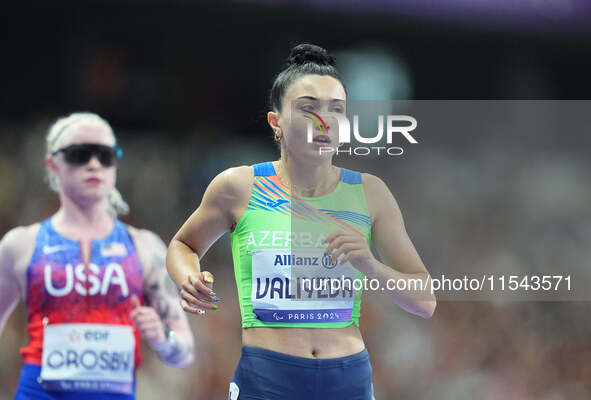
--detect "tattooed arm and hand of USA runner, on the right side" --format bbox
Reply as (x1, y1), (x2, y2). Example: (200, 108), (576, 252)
(130, 229), (194, 368)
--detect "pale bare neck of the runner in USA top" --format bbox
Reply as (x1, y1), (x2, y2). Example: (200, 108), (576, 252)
(52, 194), (114, 240)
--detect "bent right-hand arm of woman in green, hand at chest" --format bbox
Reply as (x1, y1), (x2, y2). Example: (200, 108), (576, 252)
(327, 174), (437, 318)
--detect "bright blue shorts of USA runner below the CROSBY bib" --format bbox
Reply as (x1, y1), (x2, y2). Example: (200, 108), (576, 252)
(14, 364), (135, 400)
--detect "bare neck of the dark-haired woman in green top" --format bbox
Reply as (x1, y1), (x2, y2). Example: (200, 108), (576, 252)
(274, 157), (339, 197)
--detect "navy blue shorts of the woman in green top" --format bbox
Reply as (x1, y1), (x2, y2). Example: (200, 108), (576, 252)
(229, 346), (373, 400)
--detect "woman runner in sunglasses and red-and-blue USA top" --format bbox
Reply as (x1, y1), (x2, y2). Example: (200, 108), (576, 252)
(0, 113), (193, 400)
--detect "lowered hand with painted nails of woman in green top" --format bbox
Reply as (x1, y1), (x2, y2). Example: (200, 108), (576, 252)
(181, 271), (219, 315)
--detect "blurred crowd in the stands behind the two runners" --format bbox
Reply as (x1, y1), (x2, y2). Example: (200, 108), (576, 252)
(0, 112), (591, 400)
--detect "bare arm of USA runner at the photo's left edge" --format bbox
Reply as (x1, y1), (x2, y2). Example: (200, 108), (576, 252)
(0, 228), (24, 334)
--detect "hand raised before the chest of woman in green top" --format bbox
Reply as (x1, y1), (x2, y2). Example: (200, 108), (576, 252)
(325, 230), (375, 272)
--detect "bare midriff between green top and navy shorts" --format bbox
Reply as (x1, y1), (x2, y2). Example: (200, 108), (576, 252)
(242, 325), (365, 358)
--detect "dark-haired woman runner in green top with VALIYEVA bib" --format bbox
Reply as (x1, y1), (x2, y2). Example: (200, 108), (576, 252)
(167, 44), (435, 400)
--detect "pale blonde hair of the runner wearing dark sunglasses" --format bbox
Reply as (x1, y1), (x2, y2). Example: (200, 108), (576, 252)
(45, 112), (129, 217)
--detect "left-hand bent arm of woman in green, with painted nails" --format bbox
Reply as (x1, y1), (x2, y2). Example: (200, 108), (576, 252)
(166, 166), (253, 314)
